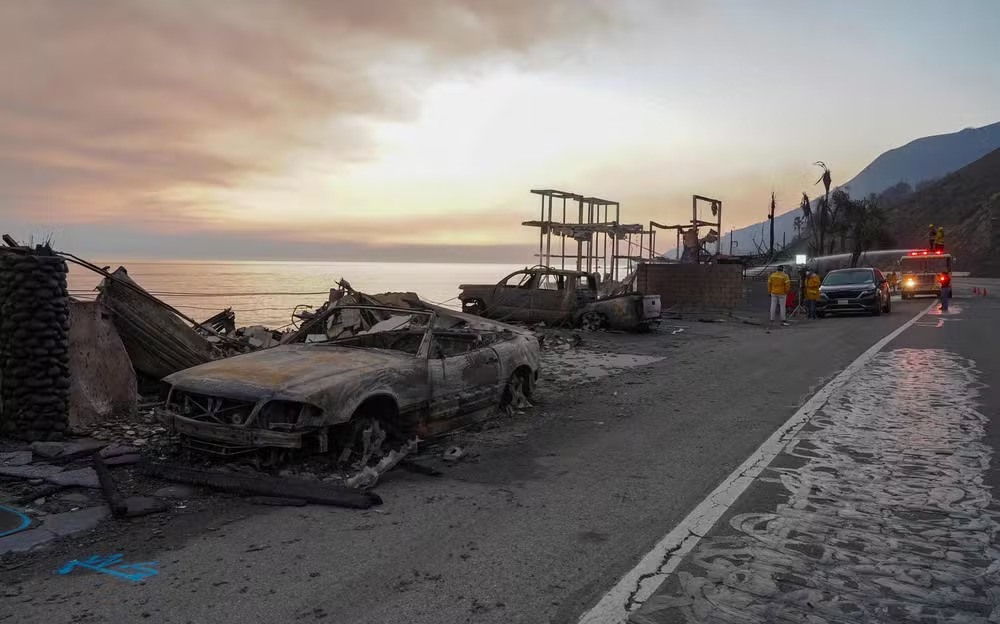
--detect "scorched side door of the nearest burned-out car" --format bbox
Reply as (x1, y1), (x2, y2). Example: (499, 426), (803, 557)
(424, 331), (500, 435)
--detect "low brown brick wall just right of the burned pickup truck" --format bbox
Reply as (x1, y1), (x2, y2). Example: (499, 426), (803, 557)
(635, 264), (746, 312)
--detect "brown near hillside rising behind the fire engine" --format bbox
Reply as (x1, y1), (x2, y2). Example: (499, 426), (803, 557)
(886, 149), (1000, 277)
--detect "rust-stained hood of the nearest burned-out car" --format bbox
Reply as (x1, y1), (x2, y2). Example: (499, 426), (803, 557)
(164, 344), (420, 407)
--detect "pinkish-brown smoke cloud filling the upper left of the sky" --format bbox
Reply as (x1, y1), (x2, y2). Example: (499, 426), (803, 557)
(0, 0), (609, 227)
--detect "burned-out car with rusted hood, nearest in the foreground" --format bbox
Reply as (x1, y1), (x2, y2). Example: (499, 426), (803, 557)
(159, 305), (539, 462)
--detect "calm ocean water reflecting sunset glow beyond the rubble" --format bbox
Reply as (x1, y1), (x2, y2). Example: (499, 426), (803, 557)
(69, 261), (524, 328)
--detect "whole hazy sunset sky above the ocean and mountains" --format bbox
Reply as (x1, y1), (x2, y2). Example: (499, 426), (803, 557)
(0, 0), (1000, 262)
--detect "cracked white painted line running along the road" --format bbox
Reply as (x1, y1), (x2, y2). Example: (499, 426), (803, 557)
(579, 301), (937, 624)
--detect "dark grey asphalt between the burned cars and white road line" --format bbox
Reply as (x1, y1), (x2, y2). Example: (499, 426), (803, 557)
(0, 291), (968, 624)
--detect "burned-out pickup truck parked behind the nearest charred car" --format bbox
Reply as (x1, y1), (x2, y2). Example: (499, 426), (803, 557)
(458, 267), (660, 331)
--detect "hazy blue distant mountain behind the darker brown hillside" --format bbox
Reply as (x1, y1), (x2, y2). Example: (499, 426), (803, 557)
(722, 122), (1000, 253)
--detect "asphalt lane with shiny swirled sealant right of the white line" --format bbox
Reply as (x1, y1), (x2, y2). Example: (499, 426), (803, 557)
(631, 281), (1000, 624)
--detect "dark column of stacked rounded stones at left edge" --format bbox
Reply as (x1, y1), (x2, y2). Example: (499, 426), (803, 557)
(0, 245), (70, 440)
